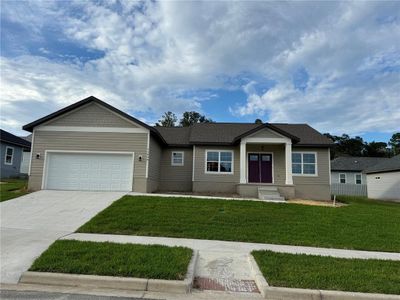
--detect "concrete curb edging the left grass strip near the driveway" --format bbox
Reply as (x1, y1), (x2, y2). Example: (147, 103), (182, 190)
(19, 251), (198, 294)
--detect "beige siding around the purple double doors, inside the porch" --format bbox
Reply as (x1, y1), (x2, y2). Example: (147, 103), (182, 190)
(246, 144), (286, 184)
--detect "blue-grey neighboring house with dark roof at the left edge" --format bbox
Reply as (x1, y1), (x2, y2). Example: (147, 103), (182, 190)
(0, 129), (31, 178)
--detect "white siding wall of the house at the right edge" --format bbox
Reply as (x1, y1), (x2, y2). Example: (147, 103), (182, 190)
(367, 171), (400, 201)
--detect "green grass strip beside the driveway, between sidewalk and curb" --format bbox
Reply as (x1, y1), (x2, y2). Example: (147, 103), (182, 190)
(29, 240), (193, 280)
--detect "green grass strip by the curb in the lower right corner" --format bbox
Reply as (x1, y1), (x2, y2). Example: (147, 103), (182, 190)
(252, 251), (400, 294)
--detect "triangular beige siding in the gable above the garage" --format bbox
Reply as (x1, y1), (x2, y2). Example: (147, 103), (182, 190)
(45, 103), (139, 128)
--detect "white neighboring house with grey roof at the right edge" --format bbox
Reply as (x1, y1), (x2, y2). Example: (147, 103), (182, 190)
(365, 154), (400, 200)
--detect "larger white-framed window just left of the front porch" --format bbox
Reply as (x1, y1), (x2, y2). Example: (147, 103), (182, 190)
(206, 150), (233, 174)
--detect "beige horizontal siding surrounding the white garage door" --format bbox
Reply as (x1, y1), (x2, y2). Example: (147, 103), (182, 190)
(29, 131), (147, 192)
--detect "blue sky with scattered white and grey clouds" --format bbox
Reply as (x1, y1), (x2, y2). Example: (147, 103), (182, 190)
(0, 0), (400, 141)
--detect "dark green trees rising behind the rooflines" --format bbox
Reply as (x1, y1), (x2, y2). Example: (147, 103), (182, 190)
(156, 111), (400, 159)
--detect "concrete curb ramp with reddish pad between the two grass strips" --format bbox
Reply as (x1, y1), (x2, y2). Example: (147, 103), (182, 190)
(193, 251), (259, 293)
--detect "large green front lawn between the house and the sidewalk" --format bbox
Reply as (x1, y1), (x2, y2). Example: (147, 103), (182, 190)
(78, 196), (400, 252)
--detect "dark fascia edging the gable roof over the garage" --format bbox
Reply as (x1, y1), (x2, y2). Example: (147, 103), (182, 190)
(22, 96), (167, 144)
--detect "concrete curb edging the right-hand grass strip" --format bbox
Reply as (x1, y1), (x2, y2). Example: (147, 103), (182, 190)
(249, 254), (400, 300)
